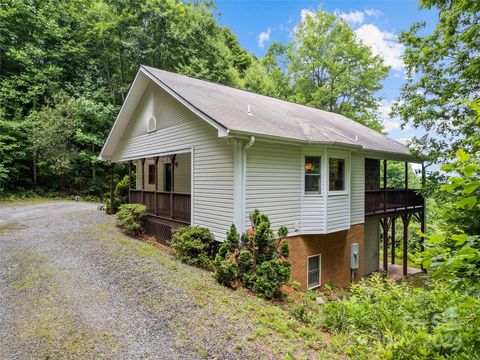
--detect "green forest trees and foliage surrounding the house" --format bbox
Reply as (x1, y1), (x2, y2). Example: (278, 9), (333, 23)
(0, 0), (480, 358)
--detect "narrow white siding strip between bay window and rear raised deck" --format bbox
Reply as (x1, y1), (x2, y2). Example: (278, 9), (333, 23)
(350, 153), (365, 225)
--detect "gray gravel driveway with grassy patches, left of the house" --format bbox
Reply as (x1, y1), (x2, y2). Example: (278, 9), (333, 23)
(0, 201), (275, 359)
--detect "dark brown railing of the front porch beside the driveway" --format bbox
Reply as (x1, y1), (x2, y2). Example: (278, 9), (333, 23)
(130, 189), (191, 223)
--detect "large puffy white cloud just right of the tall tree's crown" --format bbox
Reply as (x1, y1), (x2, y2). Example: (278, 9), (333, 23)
(355, 24), (405, 70)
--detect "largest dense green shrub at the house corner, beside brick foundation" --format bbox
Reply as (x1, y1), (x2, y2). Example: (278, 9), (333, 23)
(214, 210), (290, 299)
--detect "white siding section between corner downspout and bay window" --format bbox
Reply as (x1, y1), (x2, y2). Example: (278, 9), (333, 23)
(245, 141), (302, 233)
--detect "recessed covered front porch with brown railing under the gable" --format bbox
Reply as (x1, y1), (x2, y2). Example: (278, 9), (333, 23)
(128, 152), (192, 227)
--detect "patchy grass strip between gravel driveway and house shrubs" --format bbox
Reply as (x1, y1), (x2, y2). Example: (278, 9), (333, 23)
(89, 223), (345, 359)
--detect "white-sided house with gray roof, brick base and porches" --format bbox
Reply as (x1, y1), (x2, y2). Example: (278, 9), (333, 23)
(100, 66), (425, 289)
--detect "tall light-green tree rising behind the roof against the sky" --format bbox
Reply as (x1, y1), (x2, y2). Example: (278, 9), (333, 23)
(288, 11), (389, 130)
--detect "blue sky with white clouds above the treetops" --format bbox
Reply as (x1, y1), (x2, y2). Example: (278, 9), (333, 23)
(215, 0), (437, 149)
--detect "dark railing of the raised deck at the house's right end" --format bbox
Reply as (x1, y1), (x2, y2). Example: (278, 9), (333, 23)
(365, 189), (424, 216)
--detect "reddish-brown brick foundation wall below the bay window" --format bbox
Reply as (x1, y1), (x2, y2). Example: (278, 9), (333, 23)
(287, 224), (364, 290)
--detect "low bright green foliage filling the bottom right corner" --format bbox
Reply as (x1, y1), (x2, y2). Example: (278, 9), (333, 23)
(323, 275), (480, 359)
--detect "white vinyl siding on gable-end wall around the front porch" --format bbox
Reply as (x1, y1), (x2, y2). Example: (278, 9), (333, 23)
(113, 81), (234, 241)
